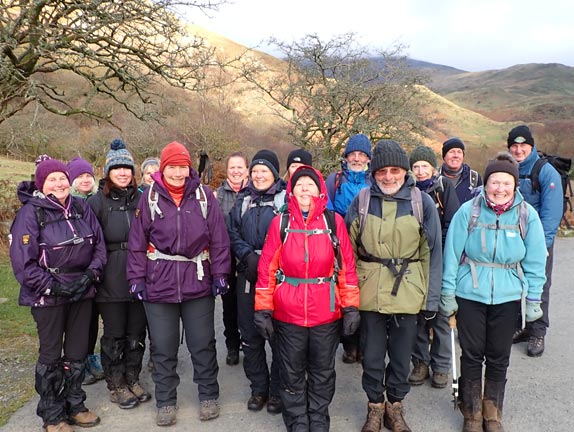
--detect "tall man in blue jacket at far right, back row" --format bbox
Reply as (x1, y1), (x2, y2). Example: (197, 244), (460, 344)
(507, 125), (563, 357)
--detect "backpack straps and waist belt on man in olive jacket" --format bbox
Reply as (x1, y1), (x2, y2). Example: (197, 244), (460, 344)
(356, 186), (424, 296)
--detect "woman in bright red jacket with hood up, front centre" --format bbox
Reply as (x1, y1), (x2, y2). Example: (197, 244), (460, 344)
(254, 165), (360, 431)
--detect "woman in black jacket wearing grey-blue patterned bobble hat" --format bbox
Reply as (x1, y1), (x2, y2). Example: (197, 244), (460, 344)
(88, 139), (151, 409)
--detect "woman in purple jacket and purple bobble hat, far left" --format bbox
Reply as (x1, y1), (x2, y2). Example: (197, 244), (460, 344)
(10, 155), (106, 432)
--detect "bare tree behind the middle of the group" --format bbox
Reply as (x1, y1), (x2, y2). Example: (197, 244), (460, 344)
(242, 33), (430, 170)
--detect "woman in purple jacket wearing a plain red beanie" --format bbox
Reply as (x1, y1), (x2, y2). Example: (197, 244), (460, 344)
(127, 141), (231, 426)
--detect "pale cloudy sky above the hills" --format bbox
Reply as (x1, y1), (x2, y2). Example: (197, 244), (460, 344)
(186, 0), (574, 71)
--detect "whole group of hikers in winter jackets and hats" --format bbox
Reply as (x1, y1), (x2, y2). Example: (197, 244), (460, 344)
(10, 125), (562, 432)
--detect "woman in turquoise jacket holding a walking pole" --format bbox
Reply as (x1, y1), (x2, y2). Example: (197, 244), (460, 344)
(440, 153), (546, 432)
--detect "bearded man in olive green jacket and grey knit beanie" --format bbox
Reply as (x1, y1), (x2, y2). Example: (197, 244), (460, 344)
(345, 140), (442, 432)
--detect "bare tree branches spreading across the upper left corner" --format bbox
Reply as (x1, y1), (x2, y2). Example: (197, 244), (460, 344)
(0, 0), (230, 123)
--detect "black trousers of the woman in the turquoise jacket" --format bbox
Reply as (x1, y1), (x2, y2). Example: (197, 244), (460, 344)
(456, 297), (520, 382)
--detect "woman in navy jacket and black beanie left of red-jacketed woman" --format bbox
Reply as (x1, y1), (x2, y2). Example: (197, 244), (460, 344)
(228, 150), (286, 414)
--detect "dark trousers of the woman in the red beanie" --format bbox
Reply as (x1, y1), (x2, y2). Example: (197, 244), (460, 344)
(144, 296), (219, 408)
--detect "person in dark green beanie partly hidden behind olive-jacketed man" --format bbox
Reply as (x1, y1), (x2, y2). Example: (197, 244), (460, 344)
(409, 146), (460, 388)
